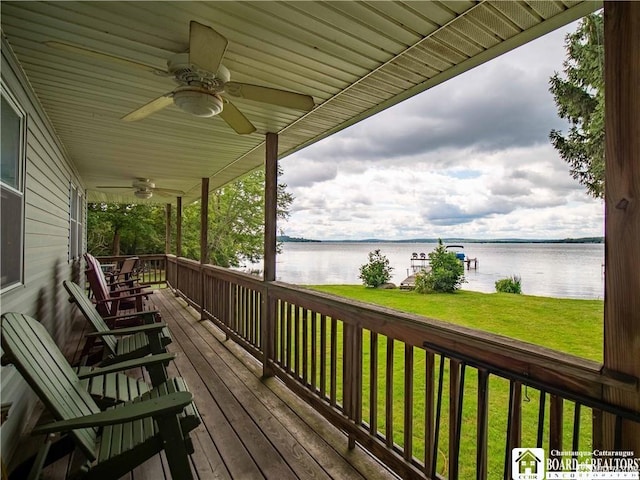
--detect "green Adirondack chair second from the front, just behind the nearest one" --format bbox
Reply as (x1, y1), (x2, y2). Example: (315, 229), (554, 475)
(62, 280), (171, 376)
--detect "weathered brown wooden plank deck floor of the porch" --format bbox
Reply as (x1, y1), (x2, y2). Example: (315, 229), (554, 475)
(32, 289), (396, 480)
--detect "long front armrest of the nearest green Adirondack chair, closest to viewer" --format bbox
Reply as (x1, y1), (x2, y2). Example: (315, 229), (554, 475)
(32, 392), (193, 435)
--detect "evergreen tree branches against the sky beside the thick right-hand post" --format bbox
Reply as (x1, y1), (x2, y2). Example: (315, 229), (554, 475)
(549, 14), (605, 198)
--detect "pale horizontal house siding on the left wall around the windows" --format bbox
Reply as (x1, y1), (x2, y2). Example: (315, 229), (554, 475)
(0, 38), (86, 465)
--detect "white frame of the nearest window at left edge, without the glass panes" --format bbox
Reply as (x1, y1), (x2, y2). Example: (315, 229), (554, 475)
(0, 81), (27, 294)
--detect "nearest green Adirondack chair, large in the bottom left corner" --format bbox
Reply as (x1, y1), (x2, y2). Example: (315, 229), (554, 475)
(2, 313), (200, 480)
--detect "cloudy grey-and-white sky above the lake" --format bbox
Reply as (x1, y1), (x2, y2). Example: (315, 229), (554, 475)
(278, 23), (604, 240)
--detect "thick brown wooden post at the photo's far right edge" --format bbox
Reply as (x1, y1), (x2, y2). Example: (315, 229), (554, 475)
(603, 1), (640, 457)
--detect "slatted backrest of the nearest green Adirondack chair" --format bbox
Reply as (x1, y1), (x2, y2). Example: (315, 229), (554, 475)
(2, 313), (100, 461)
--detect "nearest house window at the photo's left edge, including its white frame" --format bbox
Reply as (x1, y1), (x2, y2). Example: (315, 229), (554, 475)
(0, 85), (25, 290)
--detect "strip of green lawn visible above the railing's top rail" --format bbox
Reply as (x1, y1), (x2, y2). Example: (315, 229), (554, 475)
(312, 285), (604, 362)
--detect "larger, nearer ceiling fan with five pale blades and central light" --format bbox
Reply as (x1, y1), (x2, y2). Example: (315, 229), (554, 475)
(46, 20), (314, 134)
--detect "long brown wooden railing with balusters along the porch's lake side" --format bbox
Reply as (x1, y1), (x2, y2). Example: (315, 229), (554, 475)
(168, 256), (640, 479)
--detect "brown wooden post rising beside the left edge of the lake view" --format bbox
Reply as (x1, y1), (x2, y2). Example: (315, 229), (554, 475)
(261, 133), (278, 377)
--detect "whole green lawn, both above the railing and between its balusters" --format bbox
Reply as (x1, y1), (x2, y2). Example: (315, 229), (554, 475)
(298, 285), (604, 478)
